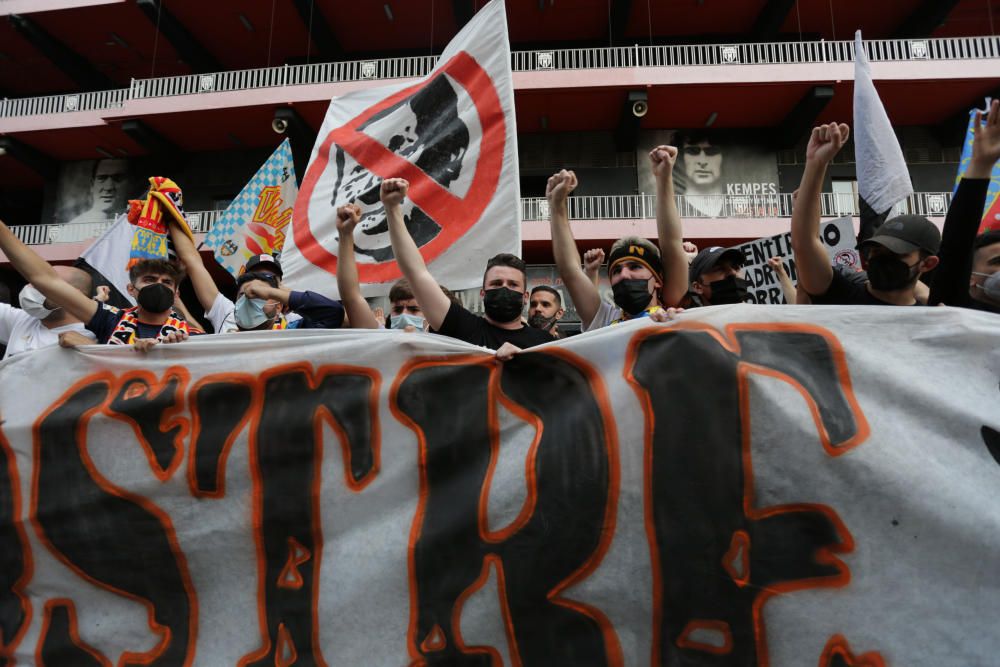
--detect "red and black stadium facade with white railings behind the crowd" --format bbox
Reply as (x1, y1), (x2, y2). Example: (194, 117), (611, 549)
(0, 0), (1000, 324)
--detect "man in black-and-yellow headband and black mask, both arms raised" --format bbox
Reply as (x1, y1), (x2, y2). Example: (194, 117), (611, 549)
(546, 146), (688, 331)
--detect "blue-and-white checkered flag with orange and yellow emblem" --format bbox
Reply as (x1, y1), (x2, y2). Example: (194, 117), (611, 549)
(205, 139), (299, 278)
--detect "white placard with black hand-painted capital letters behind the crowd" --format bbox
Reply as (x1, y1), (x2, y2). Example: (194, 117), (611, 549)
(736, 218), (861, 304)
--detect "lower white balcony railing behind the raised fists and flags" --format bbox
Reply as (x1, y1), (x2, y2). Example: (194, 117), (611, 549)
(11, 192), (951, 245)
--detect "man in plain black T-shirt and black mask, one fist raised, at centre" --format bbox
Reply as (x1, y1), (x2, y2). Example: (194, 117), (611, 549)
(380, 178), (552, 350)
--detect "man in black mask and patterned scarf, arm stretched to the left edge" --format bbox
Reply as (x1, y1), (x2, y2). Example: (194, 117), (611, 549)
(0, 222), (202, 351)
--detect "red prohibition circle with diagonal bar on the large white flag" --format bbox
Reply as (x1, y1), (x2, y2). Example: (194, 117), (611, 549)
(294, 51), (507, 283)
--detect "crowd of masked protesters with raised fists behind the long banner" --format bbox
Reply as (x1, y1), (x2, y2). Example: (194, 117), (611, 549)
(0, 101), (1000, 359)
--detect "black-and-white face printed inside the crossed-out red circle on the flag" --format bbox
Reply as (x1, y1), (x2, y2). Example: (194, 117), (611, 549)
(330, 75), (471, 263)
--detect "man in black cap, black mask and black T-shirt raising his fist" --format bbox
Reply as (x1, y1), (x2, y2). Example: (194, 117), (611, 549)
(792, 123), (941, 306)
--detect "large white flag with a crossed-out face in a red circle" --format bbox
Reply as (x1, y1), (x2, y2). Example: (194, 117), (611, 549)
(283, 1), (520, 296)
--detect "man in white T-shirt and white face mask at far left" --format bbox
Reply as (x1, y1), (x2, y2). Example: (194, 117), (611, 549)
(0, 266), (97, 359)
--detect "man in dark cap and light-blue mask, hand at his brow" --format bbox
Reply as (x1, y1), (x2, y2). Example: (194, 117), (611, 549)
(232, 271), (344, 333)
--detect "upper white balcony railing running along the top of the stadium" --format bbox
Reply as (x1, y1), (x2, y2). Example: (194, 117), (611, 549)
(0, 36), (1000, 118)
